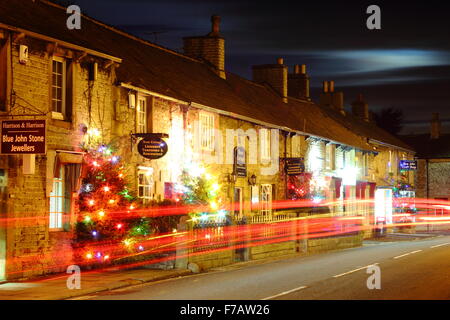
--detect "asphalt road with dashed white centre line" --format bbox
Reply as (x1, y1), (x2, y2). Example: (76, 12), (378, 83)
(82, 236), (450, 300)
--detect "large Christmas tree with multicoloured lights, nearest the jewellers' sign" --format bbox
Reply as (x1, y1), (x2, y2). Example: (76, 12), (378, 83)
(74, 145), (150, 263)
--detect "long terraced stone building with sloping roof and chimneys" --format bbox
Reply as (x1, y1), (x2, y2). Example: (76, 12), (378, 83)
(0, 0), (413, 279)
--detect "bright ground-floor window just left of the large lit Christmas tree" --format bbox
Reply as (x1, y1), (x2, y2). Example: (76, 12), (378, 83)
(49, 166), (65, 230)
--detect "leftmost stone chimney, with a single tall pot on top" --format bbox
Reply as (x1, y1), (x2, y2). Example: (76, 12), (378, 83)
(183, 15), (226, 79)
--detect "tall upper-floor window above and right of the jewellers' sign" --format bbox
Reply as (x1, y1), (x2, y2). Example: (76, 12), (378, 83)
(52, 57), (66, 115)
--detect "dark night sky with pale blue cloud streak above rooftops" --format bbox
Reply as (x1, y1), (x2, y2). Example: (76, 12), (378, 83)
(68, 0), (450, 133)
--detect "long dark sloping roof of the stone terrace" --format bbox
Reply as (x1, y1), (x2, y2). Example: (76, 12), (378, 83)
(0, 0), (410, 150)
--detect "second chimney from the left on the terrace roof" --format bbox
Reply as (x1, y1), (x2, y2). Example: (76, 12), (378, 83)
(252, 58), (288, 103)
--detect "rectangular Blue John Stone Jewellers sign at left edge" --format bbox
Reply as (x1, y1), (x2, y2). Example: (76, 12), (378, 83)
(1, 120), (45, 154)
